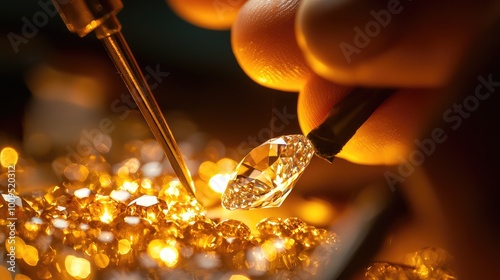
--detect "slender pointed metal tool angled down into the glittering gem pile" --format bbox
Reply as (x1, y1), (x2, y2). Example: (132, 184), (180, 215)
(53, 0), (195, 197)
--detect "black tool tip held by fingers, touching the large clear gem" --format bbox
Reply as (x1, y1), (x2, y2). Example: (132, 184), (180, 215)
(307, 88), (395, 162)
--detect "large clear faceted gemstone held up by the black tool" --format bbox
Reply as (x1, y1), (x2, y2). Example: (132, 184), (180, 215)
(222, 135), (314, 210)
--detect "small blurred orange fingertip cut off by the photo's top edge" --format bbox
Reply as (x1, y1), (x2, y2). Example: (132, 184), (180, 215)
(167, 0), (246, 30)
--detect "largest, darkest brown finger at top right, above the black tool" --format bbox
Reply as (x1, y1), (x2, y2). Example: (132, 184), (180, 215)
(297, 0), (499, 87)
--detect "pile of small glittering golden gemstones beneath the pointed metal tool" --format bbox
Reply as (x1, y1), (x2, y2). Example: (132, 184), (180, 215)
(0, 142), (339, 280)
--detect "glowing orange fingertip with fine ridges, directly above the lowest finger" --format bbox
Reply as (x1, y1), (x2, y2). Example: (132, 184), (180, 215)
(231, 0), (311, 91)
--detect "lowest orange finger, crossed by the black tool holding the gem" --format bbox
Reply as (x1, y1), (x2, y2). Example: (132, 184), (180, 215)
(297, 75), (436, 165)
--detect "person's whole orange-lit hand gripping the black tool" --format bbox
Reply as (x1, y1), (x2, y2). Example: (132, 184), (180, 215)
(168, 0), (498, 164)
